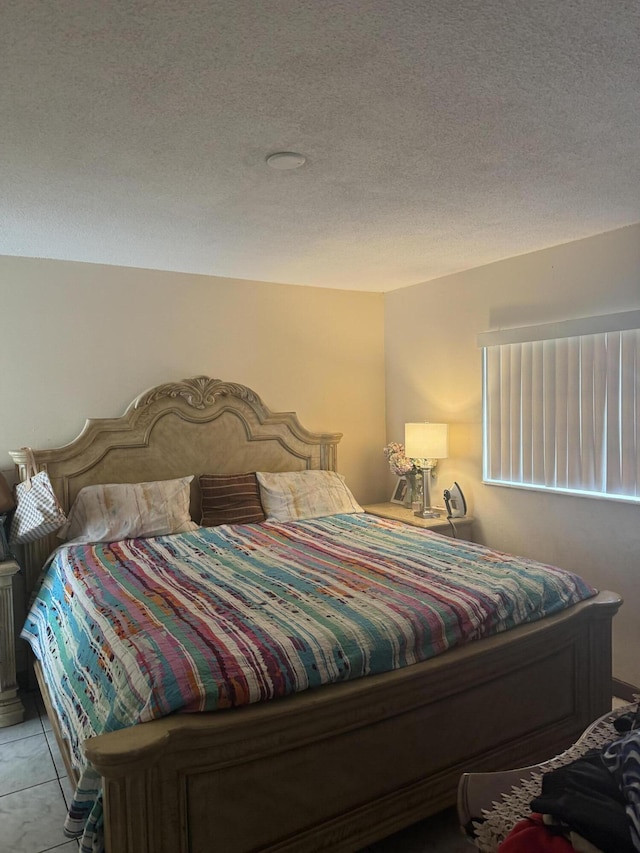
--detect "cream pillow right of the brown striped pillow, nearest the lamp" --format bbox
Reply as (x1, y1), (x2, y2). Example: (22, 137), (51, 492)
(256, 471), (364, 521)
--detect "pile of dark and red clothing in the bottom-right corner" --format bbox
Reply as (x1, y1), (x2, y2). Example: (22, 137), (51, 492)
(498, 708), (640, 853)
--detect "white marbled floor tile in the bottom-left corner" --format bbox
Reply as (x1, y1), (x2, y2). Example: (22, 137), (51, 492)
(0, 780), (70, 853)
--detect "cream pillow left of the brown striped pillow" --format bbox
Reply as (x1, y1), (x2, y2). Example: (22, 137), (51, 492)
(58, 476), (198, 542)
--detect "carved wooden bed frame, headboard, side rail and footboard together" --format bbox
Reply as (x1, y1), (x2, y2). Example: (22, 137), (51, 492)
(11, 377), (621, 853)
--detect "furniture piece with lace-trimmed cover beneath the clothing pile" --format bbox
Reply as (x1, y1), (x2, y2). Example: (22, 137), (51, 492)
(458, 702), (638, 853)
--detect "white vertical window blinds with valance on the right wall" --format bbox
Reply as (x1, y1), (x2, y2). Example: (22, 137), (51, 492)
(479, 311), (640, 501)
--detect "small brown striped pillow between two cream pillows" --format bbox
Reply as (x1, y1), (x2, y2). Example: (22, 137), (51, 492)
(200, 474), (266, 527)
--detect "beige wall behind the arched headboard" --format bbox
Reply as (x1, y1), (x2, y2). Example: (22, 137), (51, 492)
(0, 257), (385, 502)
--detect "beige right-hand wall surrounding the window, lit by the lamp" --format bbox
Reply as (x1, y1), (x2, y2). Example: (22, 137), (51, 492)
(385, 226), (640, 685)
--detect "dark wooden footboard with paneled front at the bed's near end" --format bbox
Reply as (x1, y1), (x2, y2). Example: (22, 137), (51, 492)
(70, 592), (621, 853)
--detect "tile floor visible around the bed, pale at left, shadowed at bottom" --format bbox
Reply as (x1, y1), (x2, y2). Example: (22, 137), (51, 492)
(0, 693), (624, 853)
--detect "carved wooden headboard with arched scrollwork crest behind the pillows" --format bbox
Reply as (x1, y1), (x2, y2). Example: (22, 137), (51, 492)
(10, 376), (342, 592)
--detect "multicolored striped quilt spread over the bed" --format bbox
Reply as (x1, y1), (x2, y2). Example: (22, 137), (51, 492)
(22, 514), (596, 850)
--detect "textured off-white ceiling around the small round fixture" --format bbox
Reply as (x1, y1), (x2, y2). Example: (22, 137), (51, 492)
(0, 0), (640, 291)
